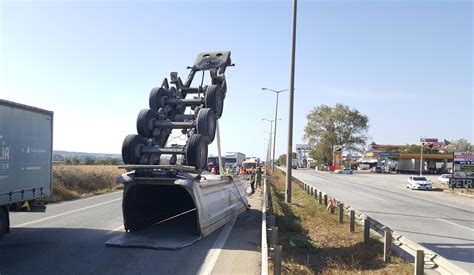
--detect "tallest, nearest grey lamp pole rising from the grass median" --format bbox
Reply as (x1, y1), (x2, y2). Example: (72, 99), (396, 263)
(285, 0), (297, 203)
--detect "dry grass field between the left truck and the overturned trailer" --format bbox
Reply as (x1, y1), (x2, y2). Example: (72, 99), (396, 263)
(48, 165), (124, 202)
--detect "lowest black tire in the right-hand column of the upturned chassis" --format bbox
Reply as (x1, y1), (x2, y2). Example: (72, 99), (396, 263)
(186, 134), (209, 170)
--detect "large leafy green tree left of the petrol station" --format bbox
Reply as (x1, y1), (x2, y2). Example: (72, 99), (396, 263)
(304, 103), (369, 165)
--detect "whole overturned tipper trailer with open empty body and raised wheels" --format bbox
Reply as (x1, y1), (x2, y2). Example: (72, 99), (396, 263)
(106, 52), (247, 249)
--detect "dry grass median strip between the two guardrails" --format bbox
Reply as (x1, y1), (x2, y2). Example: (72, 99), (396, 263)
(270, 171), (413, 274)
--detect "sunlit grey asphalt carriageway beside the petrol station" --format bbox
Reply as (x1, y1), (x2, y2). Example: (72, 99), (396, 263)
(292, 169), (474, 274)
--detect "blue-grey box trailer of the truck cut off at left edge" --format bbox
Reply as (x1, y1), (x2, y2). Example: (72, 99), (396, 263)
(0, 99), (53, 237)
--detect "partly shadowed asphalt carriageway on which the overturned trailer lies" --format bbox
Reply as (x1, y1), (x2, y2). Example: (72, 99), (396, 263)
(0, 192), (260, 275)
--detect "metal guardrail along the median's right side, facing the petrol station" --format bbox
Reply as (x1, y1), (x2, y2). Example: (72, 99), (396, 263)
(278, 167), (469, 275)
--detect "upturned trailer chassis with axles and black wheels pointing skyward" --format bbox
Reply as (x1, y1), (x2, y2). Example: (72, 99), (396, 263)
(122, 51), (233, 169)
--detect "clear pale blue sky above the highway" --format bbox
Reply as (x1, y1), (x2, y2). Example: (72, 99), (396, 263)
(0, 0), (474, 160)
